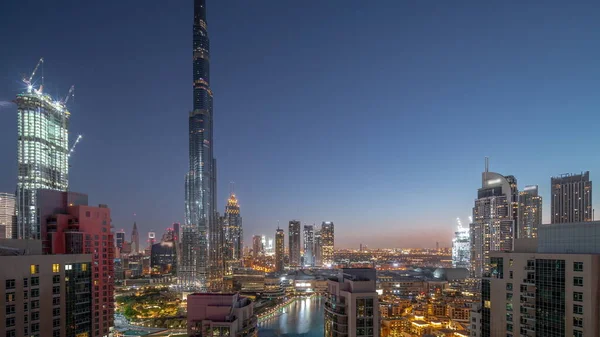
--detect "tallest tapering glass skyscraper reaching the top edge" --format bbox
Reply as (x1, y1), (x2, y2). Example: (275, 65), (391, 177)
(178, 0), (222, 291)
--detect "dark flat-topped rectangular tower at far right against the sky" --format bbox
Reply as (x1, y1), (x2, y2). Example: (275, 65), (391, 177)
(550, 171), (594, 223)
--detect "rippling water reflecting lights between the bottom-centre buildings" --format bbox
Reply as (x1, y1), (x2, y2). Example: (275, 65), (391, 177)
(258, 296), (325, 337)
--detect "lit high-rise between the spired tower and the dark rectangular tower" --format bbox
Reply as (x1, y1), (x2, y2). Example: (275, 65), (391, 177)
(516, 185), (542, 239)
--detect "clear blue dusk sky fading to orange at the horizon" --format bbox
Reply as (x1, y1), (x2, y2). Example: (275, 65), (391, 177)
(0, 0), (600, 247)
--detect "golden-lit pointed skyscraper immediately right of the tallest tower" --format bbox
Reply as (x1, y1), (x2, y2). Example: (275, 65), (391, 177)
(223, 193), (243, 275)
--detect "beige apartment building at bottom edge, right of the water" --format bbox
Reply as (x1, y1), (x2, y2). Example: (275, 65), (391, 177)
(324, 268), (380, 337)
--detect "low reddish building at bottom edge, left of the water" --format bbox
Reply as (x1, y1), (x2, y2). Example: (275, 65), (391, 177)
(187, 293), (258, 337)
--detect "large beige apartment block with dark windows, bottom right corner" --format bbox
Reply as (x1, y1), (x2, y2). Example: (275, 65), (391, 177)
(480, 221), (600, 337)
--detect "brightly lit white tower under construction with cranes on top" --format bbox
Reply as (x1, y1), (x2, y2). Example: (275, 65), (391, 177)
(12, 87), (70, 240)
